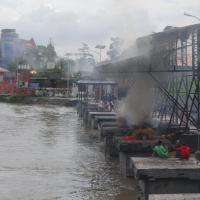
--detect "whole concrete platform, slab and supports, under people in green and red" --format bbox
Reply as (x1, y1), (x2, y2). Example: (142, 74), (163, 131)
(131, 157), (200, 200)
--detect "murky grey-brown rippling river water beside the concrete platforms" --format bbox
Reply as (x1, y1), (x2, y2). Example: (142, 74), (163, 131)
(0, 104), (136, 200)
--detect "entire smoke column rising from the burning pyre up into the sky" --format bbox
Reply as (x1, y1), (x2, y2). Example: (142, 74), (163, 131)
(94, 0), (168, 125)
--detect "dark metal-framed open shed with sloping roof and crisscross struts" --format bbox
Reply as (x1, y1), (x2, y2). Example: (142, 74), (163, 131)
(96, 24), (200, 131)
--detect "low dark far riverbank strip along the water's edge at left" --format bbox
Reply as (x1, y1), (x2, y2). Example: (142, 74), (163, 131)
(0, 95), (76, 106)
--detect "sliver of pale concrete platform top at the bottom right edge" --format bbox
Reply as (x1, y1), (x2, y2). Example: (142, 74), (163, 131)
(149, 194), (200, 200)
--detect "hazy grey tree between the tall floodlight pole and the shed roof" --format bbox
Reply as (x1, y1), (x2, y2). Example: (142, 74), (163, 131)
(107, 37), (123, 60)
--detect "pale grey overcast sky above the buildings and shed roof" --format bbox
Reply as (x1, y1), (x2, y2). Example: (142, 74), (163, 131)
(0, 0), (200, 55)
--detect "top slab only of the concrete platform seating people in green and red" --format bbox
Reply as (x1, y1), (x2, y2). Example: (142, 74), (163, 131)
(131, 157), (200, 180)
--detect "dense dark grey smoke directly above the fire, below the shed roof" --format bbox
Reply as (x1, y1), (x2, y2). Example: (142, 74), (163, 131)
(119, 74), (155, 125)
